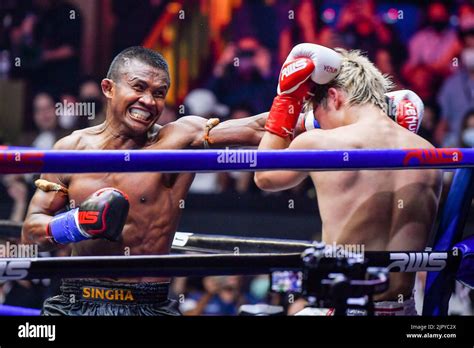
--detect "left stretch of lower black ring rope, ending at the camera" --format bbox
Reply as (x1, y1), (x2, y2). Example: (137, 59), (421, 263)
(0, 253), (301, 280)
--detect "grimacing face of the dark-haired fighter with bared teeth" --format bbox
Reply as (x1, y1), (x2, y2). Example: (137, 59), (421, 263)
(106, 59), (169, 135)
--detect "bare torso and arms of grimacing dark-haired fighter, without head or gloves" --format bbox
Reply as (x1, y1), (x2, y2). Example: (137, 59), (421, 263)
(22, 114), (266, 282)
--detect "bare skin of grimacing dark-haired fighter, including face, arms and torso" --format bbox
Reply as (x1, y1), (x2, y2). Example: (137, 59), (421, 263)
(22, 60), (265, 282)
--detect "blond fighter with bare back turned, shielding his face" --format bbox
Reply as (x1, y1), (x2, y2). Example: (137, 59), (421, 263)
(255, 44), (441, 315)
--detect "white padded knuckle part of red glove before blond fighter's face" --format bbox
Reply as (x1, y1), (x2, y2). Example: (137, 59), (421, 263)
(283, 43), (342, 85)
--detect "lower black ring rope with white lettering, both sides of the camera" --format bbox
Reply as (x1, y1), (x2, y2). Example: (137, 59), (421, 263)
(0, 247), (464, 280)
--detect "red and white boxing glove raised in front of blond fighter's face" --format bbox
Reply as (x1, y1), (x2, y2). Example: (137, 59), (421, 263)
(265, 44), (341, 138)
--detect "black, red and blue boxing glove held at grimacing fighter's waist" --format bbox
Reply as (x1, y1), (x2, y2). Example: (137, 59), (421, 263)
(48, 188), (129, 244)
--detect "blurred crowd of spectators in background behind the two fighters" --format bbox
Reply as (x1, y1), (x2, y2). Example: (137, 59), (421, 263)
(0, 0), (474, 314)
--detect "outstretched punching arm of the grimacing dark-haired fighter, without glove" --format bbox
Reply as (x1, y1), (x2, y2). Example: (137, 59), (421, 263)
(157, 113), (268, 149)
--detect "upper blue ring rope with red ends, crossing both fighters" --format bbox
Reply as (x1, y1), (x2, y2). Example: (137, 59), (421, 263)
(0, 148), (474, 174)
